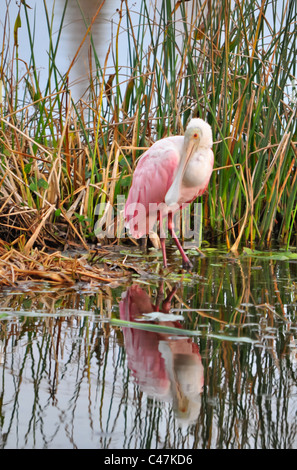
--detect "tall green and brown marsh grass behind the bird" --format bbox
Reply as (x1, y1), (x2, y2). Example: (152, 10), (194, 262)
(0, 0), (297, 255)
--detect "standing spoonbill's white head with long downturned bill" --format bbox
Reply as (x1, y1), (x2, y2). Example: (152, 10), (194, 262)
(165, 118), (213, 206)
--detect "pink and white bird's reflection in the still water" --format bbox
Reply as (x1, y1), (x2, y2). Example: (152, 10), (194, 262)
(120, 285), (204, 425)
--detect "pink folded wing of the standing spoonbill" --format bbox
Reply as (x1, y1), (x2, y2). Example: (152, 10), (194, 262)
(125, 139), (180, 238)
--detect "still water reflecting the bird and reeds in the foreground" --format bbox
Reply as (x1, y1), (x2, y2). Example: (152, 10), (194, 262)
(0, 251), (297, 449)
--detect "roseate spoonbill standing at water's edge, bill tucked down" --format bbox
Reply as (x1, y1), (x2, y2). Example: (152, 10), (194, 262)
(125, 118), (214, 268)
